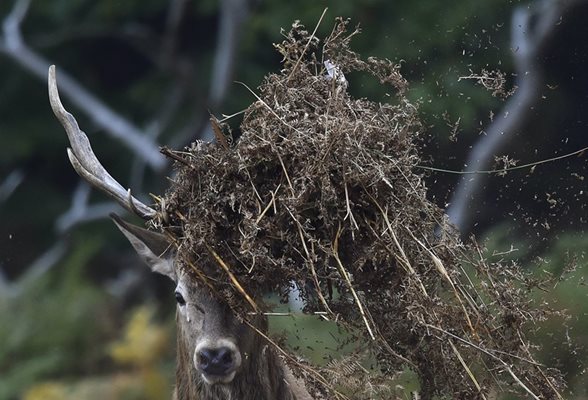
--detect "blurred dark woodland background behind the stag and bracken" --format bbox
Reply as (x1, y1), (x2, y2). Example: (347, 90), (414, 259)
(0, 0), (588, 400)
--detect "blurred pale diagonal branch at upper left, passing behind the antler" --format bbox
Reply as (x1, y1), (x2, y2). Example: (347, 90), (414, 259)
(0, 0), (166, 171)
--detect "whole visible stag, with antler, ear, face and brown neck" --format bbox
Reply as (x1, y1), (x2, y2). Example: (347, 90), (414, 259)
(48, 65), (313, 400)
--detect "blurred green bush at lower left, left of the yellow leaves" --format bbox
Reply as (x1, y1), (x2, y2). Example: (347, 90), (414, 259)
(0, 236), (109, 399)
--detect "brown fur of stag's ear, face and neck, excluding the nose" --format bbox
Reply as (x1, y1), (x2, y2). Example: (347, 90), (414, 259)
(113, 215), (312, 400)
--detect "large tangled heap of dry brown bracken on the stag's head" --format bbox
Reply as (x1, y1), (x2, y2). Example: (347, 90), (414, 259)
(154, 20), (563, 399)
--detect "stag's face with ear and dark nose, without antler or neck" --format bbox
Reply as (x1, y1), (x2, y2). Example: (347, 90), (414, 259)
(111, 214), (263, 385)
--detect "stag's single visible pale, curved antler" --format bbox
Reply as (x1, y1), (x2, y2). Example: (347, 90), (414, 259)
(48, 65), (156, 219)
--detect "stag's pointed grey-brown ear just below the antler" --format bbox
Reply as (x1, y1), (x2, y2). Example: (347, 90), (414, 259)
(110, 213), (177, 282)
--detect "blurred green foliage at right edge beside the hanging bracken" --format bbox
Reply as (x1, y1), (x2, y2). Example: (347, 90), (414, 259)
(484, 224), (588, 398)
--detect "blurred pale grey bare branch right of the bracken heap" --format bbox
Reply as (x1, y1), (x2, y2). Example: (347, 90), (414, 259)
(447, 0), (577, 236)
